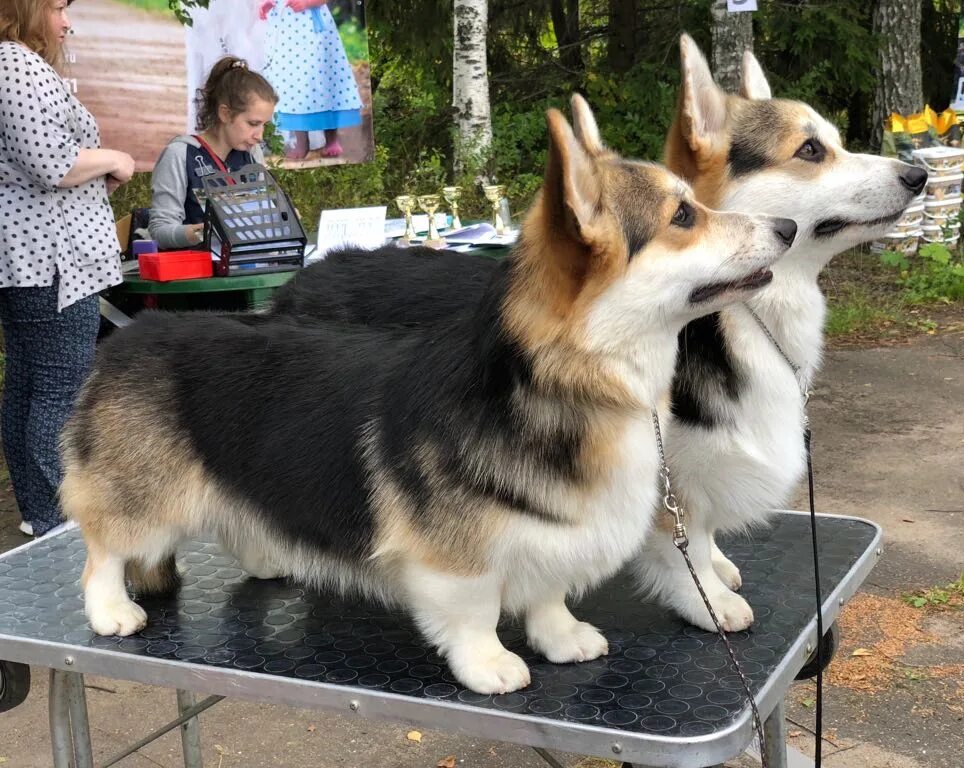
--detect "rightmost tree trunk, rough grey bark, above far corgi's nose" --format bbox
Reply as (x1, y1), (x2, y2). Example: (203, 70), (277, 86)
(871, 0), (924, 150)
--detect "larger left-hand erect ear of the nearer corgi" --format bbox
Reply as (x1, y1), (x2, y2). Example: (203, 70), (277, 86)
(543, 109), (602, 244)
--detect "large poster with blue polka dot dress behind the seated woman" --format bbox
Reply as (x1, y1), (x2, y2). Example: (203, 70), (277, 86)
(67, 0), (374, 171)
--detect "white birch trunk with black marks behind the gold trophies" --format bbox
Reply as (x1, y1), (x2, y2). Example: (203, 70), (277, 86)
(452, 0), (492, 173)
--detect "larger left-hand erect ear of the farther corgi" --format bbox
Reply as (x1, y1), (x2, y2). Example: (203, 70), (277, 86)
(678, 34), (726, 154)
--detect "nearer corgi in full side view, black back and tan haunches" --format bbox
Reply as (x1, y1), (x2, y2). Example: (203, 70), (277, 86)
(61, 99), (796, 693)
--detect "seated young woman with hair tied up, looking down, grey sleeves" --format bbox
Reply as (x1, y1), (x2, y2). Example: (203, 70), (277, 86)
(148, 56), (278, 250)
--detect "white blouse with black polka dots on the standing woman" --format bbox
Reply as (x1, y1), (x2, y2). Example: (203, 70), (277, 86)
(0, 42), (121, 309)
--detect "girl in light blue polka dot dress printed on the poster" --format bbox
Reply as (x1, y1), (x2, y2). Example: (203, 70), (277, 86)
(260, 0), (362, 160)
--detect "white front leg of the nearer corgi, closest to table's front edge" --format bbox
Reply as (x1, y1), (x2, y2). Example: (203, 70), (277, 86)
(403, 562), (531, 693)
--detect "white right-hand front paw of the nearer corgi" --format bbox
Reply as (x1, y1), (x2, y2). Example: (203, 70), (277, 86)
(526, 591), (609, 664)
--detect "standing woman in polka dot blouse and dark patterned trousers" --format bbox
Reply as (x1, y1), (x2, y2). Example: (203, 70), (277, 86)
(0, 0), (134, 536)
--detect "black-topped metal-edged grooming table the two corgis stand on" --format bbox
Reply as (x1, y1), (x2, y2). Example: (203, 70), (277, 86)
(0, 512), (881, 768)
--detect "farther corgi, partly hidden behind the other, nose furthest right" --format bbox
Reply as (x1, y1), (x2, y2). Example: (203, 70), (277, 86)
(266, 48), (927, 631)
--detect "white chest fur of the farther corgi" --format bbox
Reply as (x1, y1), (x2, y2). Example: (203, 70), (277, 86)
(667, 283), (824, 529)
